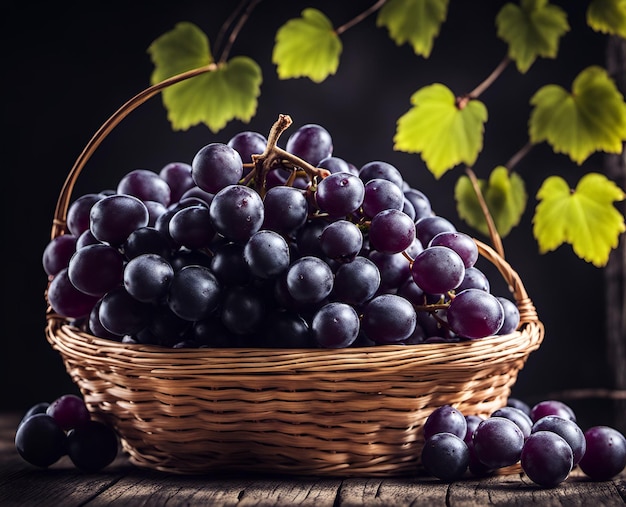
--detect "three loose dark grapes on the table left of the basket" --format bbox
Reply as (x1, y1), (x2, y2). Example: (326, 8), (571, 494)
(15, 394), (119, 472)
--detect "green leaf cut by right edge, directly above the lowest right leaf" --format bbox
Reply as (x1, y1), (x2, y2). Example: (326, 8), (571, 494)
(529, 66), (626, 165)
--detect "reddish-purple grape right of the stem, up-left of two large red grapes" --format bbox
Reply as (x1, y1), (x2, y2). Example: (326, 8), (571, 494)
(369, 209), (415, 254)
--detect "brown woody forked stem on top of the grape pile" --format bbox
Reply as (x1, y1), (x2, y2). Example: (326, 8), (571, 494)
(250, 114), (330, 196)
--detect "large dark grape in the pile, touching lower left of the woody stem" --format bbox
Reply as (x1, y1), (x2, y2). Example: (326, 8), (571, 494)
(209, 185), (264, 242)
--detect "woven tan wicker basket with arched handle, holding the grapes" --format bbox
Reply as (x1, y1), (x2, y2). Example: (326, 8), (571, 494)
(46, 69), (543, 477)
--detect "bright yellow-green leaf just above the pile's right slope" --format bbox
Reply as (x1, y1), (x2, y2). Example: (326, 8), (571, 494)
(393, 87), (487, 179)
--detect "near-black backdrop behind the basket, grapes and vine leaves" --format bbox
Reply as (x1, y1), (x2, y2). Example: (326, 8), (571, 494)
(0, 0), (611, 430)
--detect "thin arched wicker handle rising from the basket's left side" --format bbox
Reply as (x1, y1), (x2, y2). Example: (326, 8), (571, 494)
(50, 63), (217, 239)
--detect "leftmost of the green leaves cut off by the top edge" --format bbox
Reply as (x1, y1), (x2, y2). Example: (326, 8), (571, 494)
(376, 0), (448, 58)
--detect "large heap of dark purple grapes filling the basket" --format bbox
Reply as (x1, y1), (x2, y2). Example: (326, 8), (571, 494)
(43, 120), (519, 348)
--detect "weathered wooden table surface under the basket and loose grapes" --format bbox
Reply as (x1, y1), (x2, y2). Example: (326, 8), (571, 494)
(0, 414), (626, 507)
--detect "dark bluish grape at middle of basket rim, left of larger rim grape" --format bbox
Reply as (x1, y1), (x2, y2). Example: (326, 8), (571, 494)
(311, 302), (360, 349)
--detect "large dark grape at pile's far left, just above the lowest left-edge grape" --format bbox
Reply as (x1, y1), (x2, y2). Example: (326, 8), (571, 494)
(68, 243), (124, 297)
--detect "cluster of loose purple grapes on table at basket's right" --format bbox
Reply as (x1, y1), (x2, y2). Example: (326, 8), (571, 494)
(421, 398), (626, 488)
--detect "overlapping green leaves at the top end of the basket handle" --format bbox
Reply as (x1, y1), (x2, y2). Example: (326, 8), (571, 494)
(148, 22), (262, 132)
